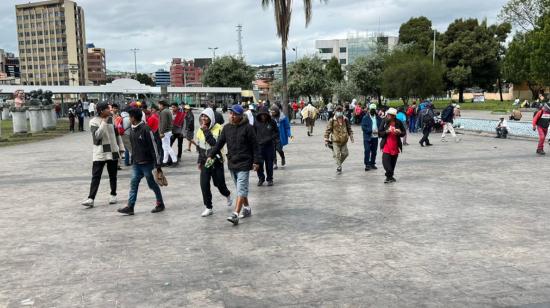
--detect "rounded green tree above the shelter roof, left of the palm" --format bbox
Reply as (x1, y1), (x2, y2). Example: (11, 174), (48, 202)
(202, 56), (255, 89)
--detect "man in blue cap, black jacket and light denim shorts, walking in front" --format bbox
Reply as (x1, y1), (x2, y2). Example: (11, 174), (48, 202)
(211, 105), (261, 225)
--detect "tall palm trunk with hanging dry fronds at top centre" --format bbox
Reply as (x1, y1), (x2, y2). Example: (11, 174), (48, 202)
(262, 0), (328, 116)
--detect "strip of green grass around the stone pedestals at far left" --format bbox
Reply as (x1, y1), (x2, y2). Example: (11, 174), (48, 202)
(0, 119), (69, 147)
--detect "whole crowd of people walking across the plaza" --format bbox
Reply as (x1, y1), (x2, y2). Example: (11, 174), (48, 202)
(75, 91), (550, 225)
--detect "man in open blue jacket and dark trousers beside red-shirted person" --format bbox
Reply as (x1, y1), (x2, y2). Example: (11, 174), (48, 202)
(361, 104), (382, 171)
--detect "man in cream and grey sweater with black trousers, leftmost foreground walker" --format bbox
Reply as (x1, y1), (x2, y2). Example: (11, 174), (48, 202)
(82, 103), (124, 208)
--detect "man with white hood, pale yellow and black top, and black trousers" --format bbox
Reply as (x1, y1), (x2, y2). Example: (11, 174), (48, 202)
(197, 108), (233, 217)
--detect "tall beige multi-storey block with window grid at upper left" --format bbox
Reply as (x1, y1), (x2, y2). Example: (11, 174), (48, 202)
(15, 0), (88, 85)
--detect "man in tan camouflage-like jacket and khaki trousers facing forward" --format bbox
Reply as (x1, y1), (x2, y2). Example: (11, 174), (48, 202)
(325, 106), (354, 174)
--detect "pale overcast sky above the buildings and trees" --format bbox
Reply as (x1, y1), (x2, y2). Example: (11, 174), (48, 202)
(0, 0), (506, 72)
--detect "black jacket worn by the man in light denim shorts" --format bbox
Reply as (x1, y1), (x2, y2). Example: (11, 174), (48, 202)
(208, 116), (260, 171)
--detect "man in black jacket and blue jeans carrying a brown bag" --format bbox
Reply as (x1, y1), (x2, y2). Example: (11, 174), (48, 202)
(118, 108), (164, 215)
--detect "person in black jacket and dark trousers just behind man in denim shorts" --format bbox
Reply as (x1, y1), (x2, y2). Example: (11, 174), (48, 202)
(254, 107), (279, 186)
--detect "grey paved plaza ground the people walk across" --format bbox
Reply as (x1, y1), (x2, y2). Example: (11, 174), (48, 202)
(0, 117), (550, 307)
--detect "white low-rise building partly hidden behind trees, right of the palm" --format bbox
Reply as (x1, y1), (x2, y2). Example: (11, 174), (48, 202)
(315, 33), (398, 67)
